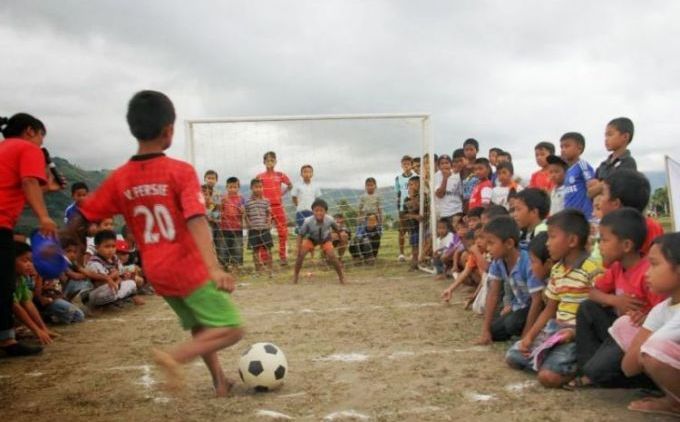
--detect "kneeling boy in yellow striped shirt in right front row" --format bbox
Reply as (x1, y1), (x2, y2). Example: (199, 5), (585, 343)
(505, 209), (601, 388)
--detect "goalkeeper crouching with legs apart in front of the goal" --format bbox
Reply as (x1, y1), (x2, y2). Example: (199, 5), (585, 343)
(293, 199), (345, 284)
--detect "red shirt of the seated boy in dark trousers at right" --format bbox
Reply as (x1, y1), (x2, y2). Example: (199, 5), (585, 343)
(595, 258), (665, 313)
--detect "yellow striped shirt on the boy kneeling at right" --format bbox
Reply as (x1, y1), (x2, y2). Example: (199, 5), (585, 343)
(545, 254), (602, 326)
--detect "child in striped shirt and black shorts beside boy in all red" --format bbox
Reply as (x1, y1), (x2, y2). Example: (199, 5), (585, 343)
(245, 179), (274, 277)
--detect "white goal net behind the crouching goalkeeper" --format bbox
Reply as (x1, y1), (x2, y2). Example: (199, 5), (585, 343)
(186, 114), (436, 276)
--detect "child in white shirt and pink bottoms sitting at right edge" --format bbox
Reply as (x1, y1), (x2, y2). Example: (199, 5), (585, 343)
(609, 233), (680, 417)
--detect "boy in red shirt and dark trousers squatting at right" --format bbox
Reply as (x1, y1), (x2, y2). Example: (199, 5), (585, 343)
(569, 208), (665, 388)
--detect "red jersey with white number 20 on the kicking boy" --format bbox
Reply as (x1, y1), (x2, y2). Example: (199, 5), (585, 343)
(80, 154), (209, 297)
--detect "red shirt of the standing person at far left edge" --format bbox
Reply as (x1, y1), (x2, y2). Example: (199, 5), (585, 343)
(0, 138), (47, 230)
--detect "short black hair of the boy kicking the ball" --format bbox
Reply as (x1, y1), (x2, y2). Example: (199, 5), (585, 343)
(127, 91), (175, 141)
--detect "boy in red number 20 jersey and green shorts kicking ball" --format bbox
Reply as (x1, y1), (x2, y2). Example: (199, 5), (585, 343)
(72, 91), (243, 396)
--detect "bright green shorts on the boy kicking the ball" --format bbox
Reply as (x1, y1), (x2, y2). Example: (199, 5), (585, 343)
(164, 281), (241, 330)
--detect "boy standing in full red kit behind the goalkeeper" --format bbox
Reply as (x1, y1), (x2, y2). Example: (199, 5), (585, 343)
(257, 151), (293, 265)
